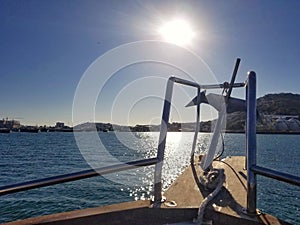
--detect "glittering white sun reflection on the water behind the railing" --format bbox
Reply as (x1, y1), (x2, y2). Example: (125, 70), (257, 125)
(126, 132), (210, 200)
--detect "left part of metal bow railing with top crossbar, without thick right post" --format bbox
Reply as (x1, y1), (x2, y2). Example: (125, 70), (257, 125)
(0, 77), (245, 207)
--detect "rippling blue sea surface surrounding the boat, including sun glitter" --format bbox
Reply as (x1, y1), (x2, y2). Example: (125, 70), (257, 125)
(0, 132), (300, 224)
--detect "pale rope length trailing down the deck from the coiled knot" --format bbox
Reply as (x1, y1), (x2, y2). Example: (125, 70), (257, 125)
(194, 169), (225, 225)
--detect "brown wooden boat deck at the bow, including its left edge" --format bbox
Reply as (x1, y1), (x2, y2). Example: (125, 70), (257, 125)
(1, 157), (289, 225)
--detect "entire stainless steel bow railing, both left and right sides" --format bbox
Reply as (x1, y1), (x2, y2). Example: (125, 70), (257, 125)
(0, 71), (300, 214)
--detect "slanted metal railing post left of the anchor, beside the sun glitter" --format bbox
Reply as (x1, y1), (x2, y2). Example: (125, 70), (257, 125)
(154, 77), (174, 207)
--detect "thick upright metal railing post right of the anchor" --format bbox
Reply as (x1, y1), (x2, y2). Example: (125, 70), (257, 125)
(246, 71), (256, 214)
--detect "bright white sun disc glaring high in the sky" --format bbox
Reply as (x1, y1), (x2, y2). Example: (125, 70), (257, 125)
(159, 19), (195, 46)
